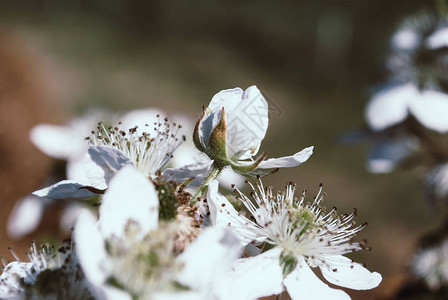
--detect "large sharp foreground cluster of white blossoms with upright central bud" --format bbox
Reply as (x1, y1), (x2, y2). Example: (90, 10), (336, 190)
(0, 86), (382, 300)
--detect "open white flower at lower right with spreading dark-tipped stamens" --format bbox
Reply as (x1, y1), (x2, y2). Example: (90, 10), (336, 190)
(207, 182), (381, 299)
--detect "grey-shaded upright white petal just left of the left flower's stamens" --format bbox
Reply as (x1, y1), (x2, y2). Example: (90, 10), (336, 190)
(85, 146), (132, 189)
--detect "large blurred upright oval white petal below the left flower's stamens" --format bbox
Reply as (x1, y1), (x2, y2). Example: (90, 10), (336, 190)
(99, 166), (159, 237)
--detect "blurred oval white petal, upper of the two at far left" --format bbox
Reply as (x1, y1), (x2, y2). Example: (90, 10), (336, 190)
(30, 124), (87, 160)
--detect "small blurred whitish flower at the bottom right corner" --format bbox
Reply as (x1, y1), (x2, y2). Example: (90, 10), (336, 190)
(412, 240), (448, 290)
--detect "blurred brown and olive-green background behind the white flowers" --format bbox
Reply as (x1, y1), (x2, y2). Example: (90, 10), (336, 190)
(0, 0), (442, 299)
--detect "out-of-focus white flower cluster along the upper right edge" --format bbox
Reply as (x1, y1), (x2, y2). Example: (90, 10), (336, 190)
(358, 13), (448, 208)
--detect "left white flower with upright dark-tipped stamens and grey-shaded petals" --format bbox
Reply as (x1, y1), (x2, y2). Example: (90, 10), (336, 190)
(33, 113), (182, 199)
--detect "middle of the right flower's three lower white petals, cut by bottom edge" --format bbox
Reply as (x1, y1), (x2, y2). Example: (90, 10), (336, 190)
(283, 257), (350, 300)
